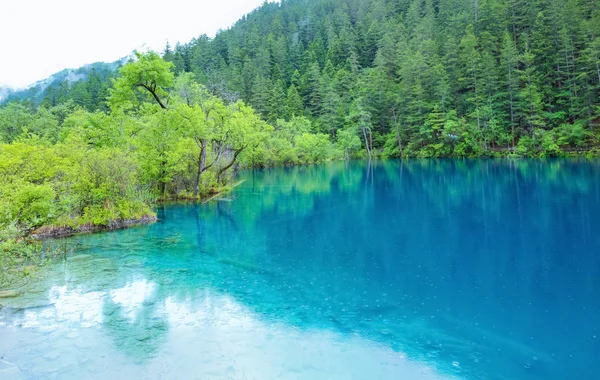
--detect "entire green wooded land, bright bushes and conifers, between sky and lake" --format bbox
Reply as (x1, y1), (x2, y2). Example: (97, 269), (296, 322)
(0, 0), (600, 280)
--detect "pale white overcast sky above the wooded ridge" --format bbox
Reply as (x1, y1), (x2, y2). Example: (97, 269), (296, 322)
(0, 0), (274, 88)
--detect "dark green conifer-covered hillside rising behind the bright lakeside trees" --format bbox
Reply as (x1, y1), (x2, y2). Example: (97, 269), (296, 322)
(1, 0), (600, 157)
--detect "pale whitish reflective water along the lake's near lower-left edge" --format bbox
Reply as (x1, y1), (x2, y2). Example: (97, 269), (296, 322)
(0, 280), (453, 380)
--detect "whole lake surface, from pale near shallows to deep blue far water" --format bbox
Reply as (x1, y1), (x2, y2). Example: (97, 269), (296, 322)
(0, 160), (600, 380)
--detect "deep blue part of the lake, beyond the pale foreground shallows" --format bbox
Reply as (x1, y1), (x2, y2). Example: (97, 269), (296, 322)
(177, 160), (600, 379)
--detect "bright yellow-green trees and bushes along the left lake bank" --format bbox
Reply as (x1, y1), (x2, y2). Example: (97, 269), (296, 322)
(0, 52), (338, 270)
